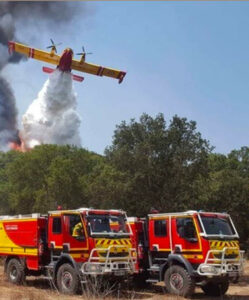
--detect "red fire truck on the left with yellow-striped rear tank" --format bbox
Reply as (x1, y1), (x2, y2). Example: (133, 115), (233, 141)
(0, 208), (137, 294)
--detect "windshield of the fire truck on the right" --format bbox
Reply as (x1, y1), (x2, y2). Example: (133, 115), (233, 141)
(201, 215), (236, 236)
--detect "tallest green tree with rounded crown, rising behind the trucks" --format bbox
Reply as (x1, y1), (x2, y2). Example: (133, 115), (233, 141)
(105, 114), (212, 215)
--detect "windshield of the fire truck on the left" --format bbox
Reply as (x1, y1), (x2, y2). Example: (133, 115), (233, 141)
(87, 214), (131, 236)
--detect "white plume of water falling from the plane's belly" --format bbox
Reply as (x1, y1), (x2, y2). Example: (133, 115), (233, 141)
(20, 69), (81, 149)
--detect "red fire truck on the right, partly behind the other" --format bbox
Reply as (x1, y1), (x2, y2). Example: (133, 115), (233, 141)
(128, 211), (244, 297)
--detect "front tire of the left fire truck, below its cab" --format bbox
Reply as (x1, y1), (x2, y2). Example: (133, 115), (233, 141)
(57, 264), (79, 295)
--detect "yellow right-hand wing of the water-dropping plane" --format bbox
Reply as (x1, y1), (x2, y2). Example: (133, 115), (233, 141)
(71, 59), (126, 83)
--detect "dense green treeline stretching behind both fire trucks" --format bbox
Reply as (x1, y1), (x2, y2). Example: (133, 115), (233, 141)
(0, 114), (249, 247)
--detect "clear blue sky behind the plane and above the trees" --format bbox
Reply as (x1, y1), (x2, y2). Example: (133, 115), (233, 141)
(5, 2), (249, 153)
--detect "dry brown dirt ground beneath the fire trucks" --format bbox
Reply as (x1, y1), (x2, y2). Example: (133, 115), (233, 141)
(0, 262), (249, 300)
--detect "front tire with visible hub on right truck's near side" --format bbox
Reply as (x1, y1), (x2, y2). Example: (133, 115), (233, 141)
(164, 265), (195, 297)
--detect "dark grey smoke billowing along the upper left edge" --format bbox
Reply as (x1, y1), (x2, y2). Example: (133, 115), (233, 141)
(0, 1), (81, 150)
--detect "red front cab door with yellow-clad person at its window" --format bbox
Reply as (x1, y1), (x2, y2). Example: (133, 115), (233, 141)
(63, 214), (88, 261)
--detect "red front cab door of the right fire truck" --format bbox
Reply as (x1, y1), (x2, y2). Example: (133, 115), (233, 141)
(172, 216), (202, 258)
